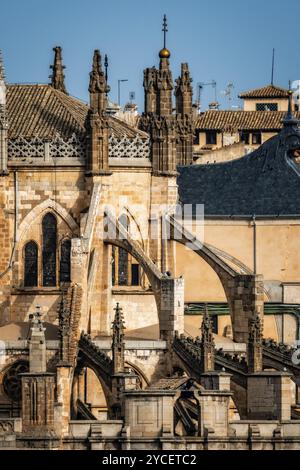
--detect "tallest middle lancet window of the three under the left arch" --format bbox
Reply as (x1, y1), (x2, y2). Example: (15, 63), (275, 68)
(42, 213), (57, 287)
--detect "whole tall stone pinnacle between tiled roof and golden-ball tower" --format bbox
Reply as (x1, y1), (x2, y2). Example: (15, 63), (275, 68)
(87, 50), (109, 175)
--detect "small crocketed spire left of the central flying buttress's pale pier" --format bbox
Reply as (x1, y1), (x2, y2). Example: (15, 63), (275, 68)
(112, 303), (125, 374)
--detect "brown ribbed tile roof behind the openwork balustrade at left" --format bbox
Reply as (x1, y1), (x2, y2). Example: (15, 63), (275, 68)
(7, 84), (148, 139)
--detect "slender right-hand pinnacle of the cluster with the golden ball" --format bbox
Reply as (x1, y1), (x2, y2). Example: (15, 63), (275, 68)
(175, 64), (193, 165)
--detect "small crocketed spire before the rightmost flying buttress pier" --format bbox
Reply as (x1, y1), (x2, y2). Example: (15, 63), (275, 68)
(248, 313), (263, 373)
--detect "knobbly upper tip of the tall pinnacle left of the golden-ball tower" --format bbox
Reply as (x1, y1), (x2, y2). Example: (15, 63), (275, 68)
(89, 49), (110, 115)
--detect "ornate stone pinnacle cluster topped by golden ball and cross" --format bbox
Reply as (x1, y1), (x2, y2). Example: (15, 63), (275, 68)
(141, 15), (193, 176)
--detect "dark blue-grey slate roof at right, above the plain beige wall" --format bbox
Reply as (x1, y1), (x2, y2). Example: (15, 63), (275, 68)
(178, 122), (300, 218)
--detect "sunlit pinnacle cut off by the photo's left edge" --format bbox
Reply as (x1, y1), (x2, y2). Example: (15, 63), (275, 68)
(0, 51), (8, 176)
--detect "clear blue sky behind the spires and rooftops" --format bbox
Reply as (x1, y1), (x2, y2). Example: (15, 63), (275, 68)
(0, 0), (300, 110)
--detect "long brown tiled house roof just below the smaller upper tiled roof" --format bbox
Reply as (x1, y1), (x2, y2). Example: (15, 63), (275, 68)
(195, 110), (300, 132)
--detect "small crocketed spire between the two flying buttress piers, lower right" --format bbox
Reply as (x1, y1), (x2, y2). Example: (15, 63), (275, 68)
(200, 305), (215, 374)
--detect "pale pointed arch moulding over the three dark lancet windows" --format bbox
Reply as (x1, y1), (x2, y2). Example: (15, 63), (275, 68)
(17, 199), (79, 241)
